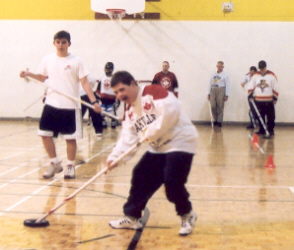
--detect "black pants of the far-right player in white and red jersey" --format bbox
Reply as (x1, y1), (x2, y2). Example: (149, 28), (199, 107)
(255, 101), (276, 132)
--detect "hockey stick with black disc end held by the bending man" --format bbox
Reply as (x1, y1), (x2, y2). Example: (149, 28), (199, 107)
(24, 138), (145, 227)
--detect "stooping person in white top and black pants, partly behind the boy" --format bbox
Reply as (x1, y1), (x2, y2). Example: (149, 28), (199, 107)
(79, 75), (103, 138)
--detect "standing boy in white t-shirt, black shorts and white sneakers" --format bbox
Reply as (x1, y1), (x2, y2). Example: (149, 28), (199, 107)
(20, 31), (101, 179)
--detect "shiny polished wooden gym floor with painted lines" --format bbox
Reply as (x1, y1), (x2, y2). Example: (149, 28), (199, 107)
(0, 121), (294, 250)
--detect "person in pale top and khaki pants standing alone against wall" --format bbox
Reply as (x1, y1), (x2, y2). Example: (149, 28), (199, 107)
(207, 61), (230, 127)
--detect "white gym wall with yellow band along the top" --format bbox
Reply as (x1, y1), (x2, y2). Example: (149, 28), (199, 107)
(0, 0), (294, 123)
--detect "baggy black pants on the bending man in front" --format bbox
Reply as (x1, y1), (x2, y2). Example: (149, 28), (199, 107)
(124, 152), (193, 218)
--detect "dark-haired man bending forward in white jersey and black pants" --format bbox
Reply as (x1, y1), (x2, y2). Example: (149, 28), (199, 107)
(106, 71), (198, 235)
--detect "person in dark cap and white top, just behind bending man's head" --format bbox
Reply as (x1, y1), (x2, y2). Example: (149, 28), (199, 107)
(96, 62), (117, 129)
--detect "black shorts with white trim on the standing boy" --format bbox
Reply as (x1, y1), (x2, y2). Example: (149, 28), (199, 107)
(38, 105), (83, 140)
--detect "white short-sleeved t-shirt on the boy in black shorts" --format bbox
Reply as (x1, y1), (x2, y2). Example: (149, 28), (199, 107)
(38, 53), (89, 109)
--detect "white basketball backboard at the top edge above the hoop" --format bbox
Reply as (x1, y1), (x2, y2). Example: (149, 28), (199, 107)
(91, 0), (145, 15)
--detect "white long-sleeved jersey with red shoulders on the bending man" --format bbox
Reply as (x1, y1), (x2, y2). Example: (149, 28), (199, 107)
(107, 85), (198, 164)
